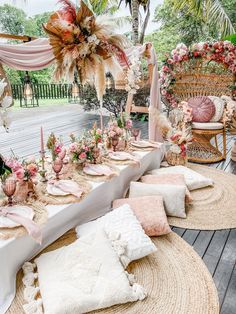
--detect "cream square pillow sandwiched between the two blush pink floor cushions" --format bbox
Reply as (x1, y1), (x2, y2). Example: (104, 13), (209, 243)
(129, 182), (186, 218)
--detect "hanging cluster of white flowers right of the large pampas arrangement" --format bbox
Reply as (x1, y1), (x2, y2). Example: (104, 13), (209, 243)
(125, 51), (142, 94)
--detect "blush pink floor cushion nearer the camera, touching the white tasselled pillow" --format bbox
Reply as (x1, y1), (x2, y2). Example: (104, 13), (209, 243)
(113, 196), (171, 236)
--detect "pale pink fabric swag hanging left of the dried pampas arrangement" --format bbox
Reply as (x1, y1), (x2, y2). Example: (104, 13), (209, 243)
(0, 38), (55, 71)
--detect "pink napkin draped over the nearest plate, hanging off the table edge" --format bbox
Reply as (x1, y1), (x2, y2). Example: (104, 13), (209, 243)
(0, 207), (42, 244)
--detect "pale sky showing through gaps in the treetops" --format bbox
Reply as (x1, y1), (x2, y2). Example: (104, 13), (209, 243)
(0, 0), (163, 34)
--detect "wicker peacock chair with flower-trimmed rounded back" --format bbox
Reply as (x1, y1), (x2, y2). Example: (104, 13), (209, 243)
(173, 62), (235, 163)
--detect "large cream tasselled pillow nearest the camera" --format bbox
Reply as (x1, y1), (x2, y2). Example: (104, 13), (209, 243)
(23, 230), (146, 314)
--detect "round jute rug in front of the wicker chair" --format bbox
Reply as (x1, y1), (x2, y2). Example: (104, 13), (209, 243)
(168, 164), (236, 230)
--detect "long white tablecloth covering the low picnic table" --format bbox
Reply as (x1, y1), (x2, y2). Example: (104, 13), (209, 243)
(0, 148), (163, 314)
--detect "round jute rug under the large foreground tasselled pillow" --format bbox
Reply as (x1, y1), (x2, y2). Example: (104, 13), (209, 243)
(7, 231), (219, 314)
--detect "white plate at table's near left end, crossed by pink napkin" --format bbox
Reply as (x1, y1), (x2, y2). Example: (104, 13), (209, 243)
(0, 205), (34, 228)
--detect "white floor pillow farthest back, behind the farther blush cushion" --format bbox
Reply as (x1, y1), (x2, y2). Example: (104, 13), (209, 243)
(151, 166), (214, 191)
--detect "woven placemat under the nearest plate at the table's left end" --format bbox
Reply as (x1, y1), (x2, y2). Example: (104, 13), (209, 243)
(0, 201), (48, 240)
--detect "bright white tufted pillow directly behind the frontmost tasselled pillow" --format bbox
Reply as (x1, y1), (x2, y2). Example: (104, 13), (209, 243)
(76, 204), (156, 267)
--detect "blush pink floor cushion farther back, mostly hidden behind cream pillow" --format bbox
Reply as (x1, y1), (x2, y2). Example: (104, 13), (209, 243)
(141, 173), (192, 203)
